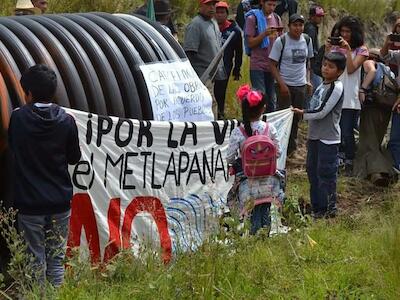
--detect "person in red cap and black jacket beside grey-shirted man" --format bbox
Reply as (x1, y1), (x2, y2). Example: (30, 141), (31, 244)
(214, 1), (243, 119)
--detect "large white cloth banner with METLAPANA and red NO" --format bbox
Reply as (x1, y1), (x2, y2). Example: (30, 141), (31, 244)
(68, 109), (293, 262)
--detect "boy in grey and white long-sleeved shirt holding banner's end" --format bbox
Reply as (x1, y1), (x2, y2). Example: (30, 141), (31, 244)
(292, 52), (346, 218)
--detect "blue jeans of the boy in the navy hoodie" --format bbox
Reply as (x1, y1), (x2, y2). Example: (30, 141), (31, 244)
(18, 210), (71, 287)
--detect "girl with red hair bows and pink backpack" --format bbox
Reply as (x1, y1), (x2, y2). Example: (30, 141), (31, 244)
(227, 85), (280, 234)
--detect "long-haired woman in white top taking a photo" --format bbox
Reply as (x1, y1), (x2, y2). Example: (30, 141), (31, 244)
(325, 16), (368, 176)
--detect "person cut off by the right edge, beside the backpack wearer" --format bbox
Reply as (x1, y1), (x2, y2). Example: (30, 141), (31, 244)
(380, 35), (400, 175)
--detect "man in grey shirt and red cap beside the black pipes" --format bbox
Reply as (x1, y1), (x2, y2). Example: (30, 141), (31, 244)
(183, 0), (226, 119)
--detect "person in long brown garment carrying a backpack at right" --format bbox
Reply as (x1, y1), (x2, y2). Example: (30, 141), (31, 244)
(354, 48), (396, 187)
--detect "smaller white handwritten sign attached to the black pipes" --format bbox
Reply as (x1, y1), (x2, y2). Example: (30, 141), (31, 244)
(140, 60), (214, 122)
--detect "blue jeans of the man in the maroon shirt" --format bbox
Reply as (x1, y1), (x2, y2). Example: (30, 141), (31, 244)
(250, 70), (276, 112)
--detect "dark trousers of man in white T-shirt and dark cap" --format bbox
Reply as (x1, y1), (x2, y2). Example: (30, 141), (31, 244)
(278, 85), (306, 155)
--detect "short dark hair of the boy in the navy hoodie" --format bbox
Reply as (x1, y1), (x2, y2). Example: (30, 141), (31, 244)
(20, 64), (57, 102)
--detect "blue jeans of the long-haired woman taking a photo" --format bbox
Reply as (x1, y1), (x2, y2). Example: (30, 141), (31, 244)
(340, 109), (360, 160)
